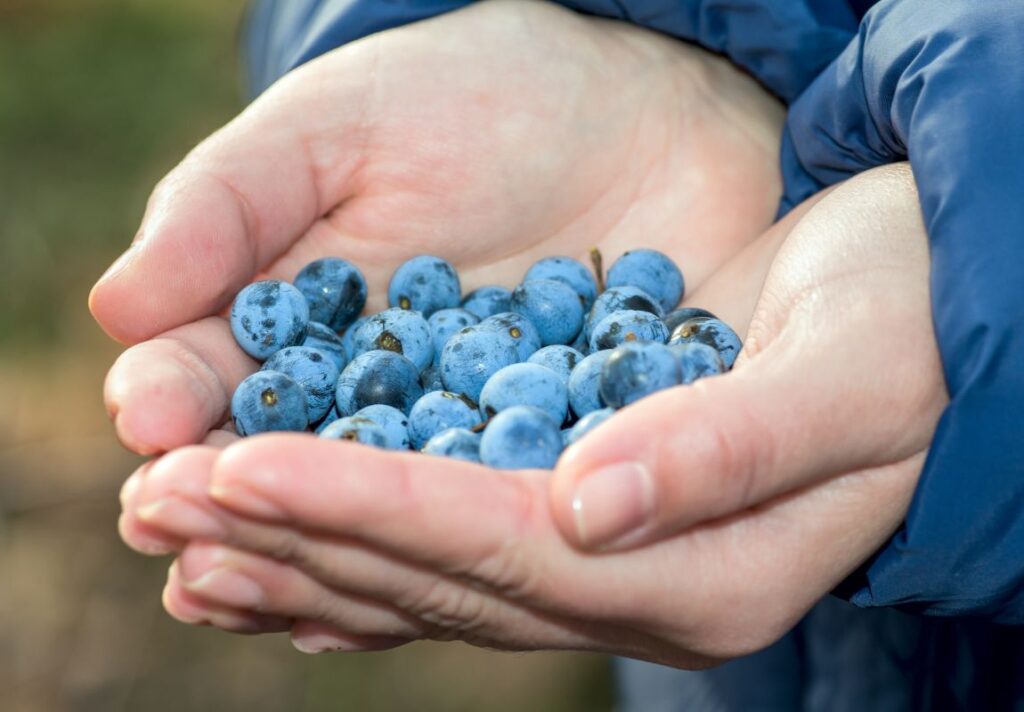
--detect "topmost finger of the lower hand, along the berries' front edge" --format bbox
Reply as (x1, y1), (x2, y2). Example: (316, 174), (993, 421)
(210, 435), (532, 577)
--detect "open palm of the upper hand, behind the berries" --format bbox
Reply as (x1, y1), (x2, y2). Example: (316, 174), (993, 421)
(271, 3), (780, 306)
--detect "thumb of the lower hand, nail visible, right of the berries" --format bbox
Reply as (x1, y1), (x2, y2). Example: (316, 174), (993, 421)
(550, 327), (928, 549)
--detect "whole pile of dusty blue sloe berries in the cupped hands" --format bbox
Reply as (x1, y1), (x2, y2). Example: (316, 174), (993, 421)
(230, 249), (741, 469)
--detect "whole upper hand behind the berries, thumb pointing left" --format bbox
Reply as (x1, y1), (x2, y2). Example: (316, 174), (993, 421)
(90, 2), (782, 454)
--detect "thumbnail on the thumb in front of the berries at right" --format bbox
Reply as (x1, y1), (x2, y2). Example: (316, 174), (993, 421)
(572, 462), (654, 546)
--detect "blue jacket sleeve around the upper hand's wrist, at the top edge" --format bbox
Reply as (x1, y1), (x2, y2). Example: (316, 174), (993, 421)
(245, 0), (864, 102)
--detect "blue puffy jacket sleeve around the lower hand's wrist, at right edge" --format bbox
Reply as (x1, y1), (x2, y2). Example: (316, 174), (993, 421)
(782, 0), (1024, 624)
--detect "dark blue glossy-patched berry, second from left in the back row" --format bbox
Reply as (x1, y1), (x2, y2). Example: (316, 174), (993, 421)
(295, 257), (367, 331)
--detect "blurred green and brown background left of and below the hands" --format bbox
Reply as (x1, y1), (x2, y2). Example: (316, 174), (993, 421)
(0, 0), (612, 712)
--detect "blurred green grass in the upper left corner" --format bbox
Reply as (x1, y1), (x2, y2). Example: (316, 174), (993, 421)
(0, 0), (243, 352)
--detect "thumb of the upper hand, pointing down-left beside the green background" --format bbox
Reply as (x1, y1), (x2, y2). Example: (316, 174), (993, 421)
(89, 52), (372, 343)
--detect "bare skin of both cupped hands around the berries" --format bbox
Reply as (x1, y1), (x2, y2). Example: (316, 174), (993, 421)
(92, 3), (945, 667)
